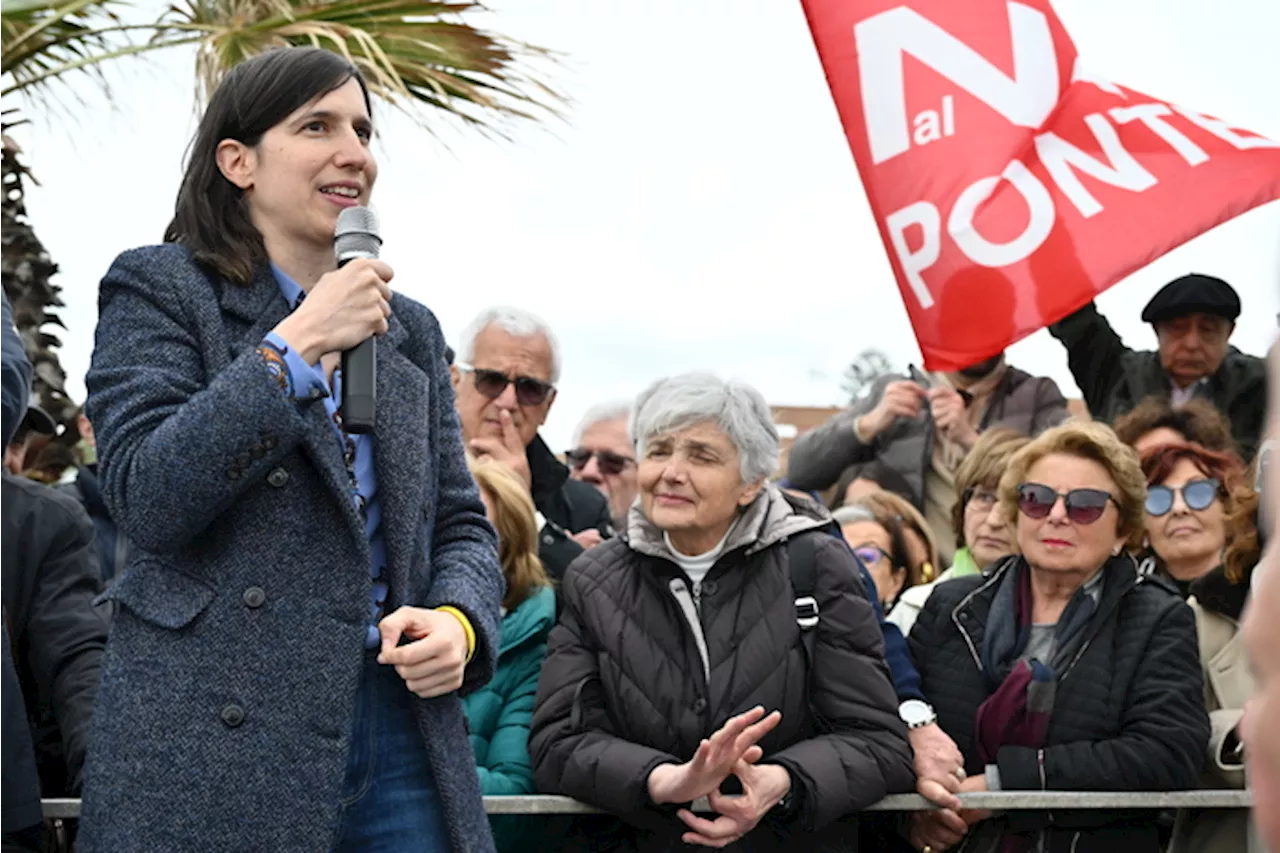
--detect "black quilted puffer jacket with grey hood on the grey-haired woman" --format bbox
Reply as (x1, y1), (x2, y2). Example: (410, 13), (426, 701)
(530, 487), (914, 853)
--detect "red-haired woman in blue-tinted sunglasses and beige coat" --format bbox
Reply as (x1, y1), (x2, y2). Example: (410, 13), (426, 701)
(1142, 443), (1260, 853)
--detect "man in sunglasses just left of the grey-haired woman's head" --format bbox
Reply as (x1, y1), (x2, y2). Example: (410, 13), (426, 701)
(564, 402), (640, 530)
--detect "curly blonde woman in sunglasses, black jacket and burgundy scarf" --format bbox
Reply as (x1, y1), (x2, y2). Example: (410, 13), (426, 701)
(909, 423), (1210, 853)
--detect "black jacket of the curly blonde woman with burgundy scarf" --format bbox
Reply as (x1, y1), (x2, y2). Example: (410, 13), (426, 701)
(910, 557), (1210, 853)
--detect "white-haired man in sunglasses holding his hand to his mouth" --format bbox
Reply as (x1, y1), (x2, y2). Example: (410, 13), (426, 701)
(449, 307), (613, 580)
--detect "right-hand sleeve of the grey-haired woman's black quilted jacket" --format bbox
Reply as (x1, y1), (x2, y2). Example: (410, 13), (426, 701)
(764, 537), (915, 830)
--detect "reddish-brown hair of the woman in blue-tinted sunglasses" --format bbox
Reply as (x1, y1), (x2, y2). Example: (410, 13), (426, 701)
(1142, 443), (1262, 584)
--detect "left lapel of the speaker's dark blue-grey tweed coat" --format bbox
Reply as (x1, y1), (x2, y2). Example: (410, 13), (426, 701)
(219, 266), (366, 540)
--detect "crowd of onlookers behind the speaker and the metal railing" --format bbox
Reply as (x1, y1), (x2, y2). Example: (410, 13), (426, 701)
(0, 261), (1266, 853)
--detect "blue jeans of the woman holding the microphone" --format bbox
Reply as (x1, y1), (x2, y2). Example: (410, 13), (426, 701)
(333, 652), (452, 853)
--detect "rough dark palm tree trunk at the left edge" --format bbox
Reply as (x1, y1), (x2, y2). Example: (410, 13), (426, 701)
(0, 110), (76, 424)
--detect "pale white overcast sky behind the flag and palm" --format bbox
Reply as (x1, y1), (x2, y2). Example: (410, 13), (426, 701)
(15, 0), (1280, 450)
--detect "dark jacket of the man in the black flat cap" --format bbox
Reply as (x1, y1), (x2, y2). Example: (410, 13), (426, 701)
(1048, 302), (1267, 461)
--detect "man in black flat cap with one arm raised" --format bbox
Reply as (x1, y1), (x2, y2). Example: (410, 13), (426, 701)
(1050, 273), (1267, 460)
